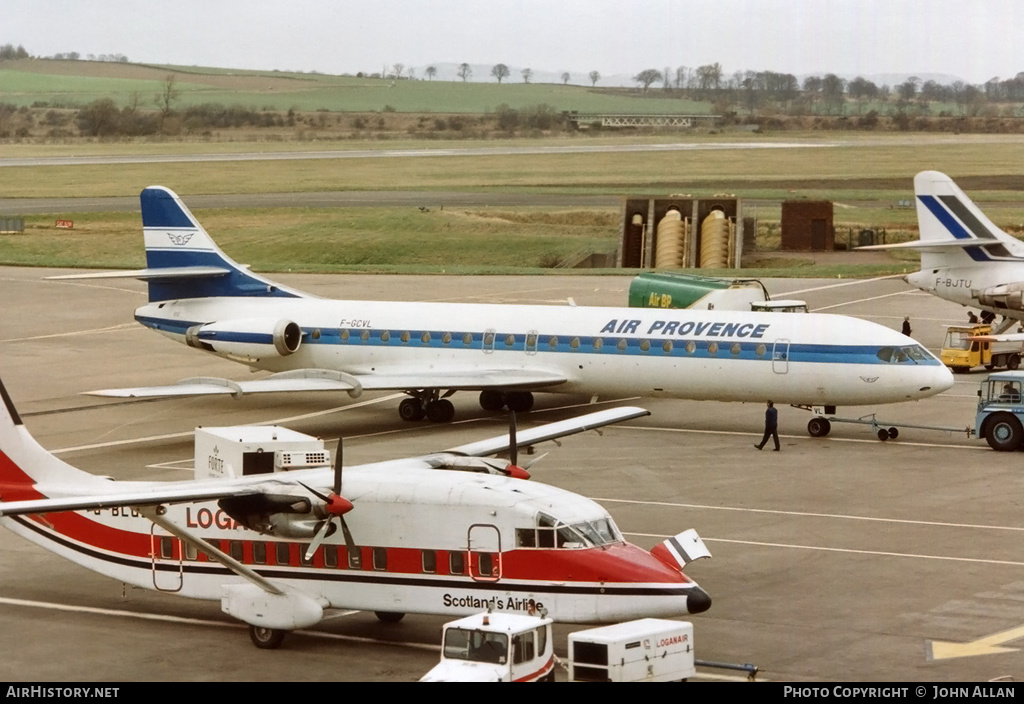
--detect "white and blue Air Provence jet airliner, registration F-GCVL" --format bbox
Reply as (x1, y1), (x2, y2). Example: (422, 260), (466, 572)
(56, 186), (952, 423)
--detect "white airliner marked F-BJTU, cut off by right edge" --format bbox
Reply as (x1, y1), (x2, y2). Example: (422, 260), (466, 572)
(859, 171), (1024, 329)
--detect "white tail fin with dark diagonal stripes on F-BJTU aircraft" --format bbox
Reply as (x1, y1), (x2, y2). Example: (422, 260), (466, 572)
(913, 171), (1024, 269)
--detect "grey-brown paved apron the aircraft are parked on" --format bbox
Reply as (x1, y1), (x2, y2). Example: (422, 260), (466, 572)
(0, 268), (1024, 683)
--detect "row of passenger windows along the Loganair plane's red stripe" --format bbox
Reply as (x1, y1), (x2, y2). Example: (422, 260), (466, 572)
(160, 535), (495, 576)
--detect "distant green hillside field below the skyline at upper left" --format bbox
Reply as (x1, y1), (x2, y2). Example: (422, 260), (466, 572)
(0, 59), (711, 114)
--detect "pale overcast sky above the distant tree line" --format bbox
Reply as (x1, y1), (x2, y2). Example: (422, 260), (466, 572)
(8, 0), (1024, 84)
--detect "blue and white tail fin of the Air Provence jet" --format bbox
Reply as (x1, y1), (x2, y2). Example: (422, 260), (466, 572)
(140, 186), (305, 303)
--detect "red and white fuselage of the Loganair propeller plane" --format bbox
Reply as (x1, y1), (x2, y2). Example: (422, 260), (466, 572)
(0, 455), (710, 622)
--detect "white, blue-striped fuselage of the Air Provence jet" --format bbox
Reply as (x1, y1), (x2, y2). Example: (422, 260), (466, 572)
(135, 298), (952, 405)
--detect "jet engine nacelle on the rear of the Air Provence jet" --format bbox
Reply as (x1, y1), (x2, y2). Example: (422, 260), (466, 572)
(185, 318), (302, 359)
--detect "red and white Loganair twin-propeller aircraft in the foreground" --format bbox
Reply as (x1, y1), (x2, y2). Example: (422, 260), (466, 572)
(0, 383), (711, 648)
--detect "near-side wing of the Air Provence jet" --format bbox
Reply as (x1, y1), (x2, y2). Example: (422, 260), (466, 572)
(86, 367), (566, 398)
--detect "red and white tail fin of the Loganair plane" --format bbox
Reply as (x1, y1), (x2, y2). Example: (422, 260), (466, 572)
(0, 381), (105, 501)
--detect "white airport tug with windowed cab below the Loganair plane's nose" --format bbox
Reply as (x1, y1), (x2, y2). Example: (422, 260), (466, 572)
(420, 612), (555, 681)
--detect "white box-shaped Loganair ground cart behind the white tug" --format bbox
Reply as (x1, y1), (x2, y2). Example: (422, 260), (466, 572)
(569, 618), (696, 681)
